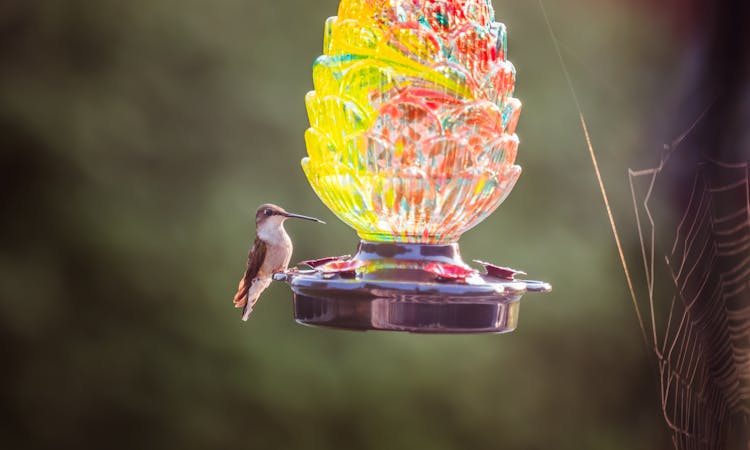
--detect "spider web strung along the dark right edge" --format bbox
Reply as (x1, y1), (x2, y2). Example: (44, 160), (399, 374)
(628, 146), (750, 449)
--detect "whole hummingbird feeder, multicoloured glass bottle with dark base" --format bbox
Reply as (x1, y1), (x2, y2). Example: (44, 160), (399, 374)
(276, 0), (550, 333)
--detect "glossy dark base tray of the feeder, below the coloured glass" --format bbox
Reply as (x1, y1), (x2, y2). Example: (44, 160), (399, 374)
(277, 242), (550, 333)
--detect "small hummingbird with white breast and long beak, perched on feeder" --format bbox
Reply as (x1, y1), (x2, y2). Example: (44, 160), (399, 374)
(234, 203), (325, 320)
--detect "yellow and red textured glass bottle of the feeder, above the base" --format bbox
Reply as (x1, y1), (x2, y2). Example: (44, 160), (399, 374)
(302, 0), (521, 244)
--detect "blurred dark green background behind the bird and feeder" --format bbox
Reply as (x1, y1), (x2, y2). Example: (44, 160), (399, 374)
(0, 0), (675, 450)
